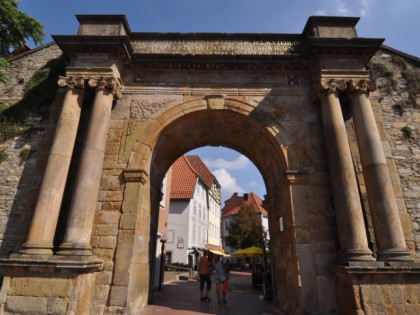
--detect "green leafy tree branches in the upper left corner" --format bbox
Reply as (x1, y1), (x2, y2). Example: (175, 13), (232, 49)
(0, 0), (45, 82)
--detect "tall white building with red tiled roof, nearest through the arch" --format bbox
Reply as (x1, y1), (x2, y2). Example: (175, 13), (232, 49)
(166, 155), (221, 266)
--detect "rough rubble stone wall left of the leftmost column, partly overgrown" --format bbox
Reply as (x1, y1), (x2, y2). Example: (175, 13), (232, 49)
(0, 44), (61, 257)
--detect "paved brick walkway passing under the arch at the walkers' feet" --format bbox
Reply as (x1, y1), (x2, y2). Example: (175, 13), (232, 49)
(140, 271), (281, 315)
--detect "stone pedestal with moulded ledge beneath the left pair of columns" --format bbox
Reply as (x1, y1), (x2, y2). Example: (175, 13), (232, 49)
(0, 255), (103, 315)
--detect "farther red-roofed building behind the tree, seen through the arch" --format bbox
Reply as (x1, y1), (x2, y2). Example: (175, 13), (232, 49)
(222, 192), (269, 254)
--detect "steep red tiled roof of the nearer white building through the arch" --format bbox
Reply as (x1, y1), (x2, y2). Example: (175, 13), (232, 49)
(171, 155), (213, 199)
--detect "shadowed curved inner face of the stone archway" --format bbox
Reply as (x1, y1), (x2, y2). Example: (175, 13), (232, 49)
(126, 99), (299, 314)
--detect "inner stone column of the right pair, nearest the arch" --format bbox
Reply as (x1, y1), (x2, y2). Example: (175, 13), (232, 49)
(320, 80), (375, 262)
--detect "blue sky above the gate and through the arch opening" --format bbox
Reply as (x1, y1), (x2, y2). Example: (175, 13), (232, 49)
(20, 0), (420, 205)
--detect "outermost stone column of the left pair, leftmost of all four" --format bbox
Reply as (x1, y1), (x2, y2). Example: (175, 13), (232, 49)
(20, 77), (84, 255)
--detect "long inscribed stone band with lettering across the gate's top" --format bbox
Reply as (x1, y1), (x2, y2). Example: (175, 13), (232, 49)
(132, 40), (301, 56)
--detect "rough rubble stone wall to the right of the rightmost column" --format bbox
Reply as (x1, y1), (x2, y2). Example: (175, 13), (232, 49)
(371, 49), (420, 257)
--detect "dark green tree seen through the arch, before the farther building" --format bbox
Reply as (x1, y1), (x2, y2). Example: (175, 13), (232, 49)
(225, 204), (264, 249)
